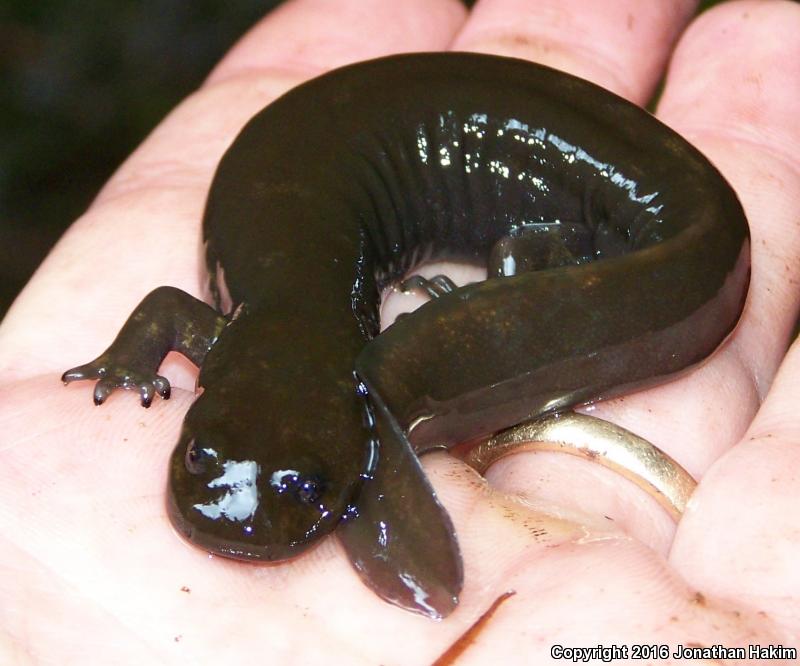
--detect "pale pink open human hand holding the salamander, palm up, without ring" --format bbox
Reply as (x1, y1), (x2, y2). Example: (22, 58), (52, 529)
(0, 0), (800, 664)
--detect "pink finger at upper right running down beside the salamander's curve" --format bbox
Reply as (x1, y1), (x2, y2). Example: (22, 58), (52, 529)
(622, 2), (800, 466)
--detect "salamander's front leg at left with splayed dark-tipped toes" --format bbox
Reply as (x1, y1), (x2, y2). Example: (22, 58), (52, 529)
(61, 287), (227, 407)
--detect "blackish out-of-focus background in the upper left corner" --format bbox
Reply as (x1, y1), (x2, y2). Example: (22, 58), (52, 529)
(0, 0), (732, 319)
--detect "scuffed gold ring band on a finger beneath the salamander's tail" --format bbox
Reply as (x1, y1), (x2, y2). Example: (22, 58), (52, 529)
(465, 412), (697, 521)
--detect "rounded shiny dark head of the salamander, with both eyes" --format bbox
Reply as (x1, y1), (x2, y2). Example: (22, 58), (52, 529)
(168, 395), (360, 561)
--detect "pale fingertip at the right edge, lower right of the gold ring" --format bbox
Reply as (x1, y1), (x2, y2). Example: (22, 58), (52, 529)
(670, 334), (800, 635)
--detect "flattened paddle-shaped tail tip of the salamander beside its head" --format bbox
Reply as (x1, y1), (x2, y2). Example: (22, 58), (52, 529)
(336, 395), (464, 620)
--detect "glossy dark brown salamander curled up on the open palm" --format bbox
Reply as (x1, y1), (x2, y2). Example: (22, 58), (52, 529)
(63, 53), (750, 617)
